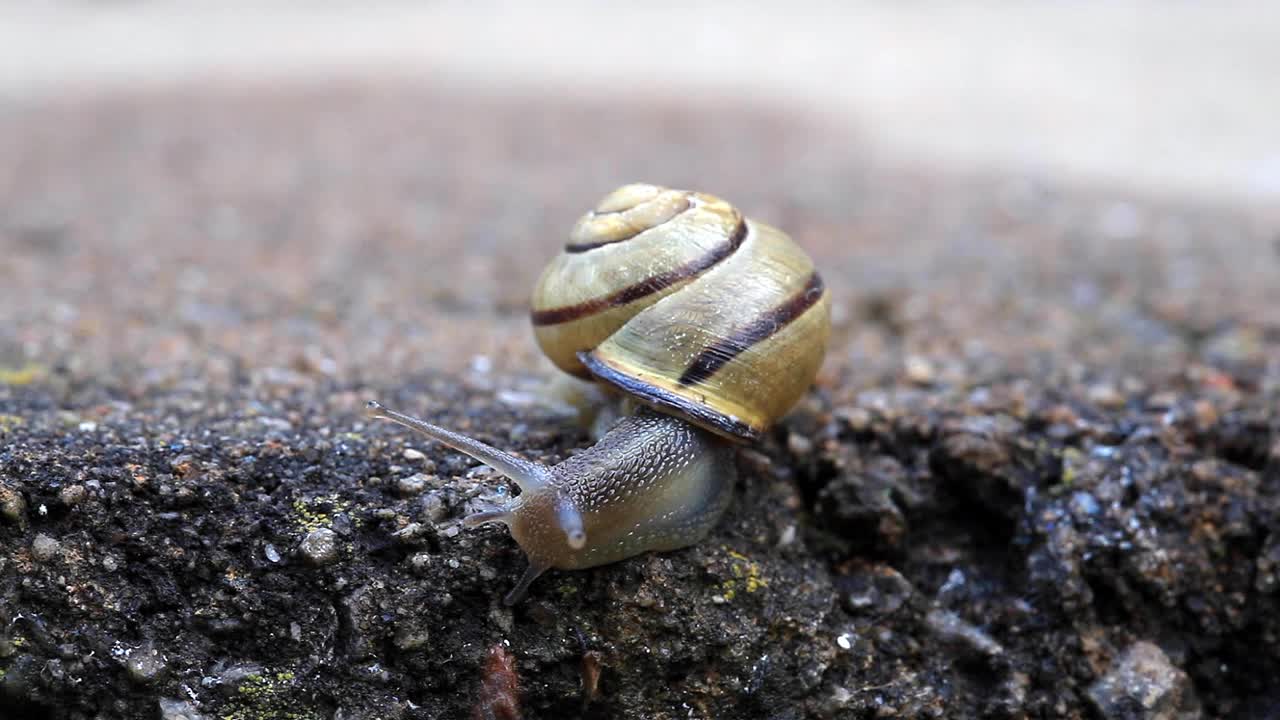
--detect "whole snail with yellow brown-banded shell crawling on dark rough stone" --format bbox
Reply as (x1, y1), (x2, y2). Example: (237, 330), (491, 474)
(369, 184), (831, 605)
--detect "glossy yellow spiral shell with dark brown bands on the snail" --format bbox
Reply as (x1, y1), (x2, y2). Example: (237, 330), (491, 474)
(531, 184), (831, 439)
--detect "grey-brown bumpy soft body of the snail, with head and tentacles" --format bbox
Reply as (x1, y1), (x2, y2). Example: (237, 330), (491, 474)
(369, 402), (737, 605)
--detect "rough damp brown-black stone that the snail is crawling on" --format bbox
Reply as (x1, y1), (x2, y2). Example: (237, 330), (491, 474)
(0, 83), (1280, 720)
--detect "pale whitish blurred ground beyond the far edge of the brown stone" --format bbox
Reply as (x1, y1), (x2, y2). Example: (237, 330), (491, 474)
(0, 0), (1280, 204)
